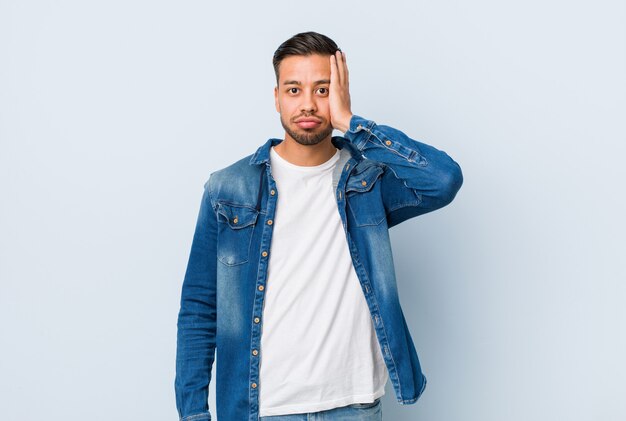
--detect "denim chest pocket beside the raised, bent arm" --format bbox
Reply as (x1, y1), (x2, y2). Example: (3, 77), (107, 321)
(346, 165), (387, 227)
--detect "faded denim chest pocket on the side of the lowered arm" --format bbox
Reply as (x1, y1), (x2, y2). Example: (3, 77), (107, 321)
(217, 202), (259, 266)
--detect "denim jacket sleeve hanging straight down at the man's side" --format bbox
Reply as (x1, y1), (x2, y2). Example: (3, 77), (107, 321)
(174, 177), (217, 421)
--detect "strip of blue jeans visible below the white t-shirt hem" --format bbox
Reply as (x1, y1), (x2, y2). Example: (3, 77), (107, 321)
(260, 398), (383, 421)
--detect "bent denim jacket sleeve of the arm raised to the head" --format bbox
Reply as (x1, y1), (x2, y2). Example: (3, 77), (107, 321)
(344, 115), (463, 228)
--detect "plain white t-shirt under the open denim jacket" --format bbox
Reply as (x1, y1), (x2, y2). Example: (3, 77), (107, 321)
(259, 147), (388, 416)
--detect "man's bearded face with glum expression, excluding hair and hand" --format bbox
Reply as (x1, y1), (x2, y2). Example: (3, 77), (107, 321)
(274, 54), (333, 145)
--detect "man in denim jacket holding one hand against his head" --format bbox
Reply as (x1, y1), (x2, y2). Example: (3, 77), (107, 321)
(175, 32), (463, 421)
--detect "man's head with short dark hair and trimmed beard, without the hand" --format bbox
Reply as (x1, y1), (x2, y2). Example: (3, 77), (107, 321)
(273, 32), (339, 145)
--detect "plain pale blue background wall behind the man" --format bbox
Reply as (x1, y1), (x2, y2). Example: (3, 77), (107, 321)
(0, 0), (626, 421)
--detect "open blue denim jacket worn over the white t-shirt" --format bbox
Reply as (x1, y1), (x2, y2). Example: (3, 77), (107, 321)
(174, 115), (463, 421)
